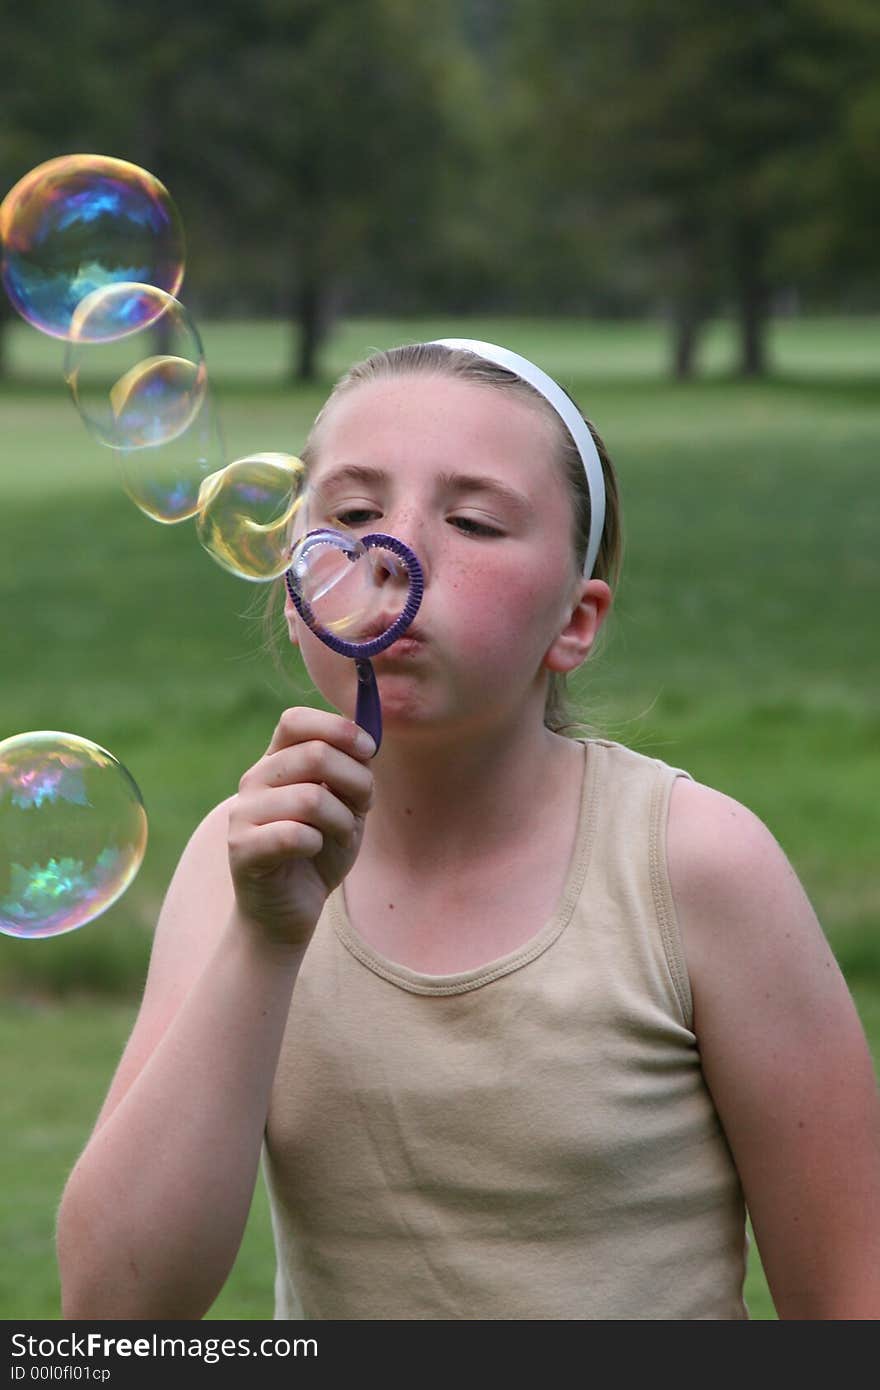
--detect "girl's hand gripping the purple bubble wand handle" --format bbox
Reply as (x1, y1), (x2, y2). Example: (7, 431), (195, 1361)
(229, 709), (375, 947)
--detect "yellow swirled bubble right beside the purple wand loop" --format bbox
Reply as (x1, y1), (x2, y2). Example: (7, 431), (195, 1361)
(196, 453), (306, 580)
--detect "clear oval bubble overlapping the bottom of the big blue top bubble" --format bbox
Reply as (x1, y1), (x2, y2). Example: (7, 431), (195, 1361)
(64, 282), (207, 449)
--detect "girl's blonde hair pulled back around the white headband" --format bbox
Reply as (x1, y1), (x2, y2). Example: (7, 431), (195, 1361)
(271, 343), (623, 734)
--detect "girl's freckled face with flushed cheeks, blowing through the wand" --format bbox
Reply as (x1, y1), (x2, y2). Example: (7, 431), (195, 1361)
(288, 374), (610, 735)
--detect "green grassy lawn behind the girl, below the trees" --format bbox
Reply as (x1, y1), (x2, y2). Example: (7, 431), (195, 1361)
(0, 309), (880, 1319)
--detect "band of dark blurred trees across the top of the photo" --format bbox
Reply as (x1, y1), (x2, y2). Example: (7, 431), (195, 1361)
(0, 0), (880, 377)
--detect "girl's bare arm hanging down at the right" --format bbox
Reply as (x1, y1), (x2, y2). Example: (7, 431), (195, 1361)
(667, 778), (880, 1319)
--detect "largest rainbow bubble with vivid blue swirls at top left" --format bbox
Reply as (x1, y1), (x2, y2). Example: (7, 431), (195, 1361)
(0, 154), (185, 338)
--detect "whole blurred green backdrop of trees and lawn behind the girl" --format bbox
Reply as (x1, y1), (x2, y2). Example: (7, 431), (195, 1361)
(0, 0), (880, 1319)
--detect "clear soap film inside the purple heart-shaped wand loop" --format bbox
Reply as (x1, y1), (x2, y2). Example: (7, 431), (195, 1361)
(289, 530), (412, 642)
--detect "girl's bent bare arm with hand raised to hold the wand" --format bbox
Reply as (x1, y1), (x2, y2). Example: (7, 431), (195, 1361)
(57, 710), (371, 1319)
